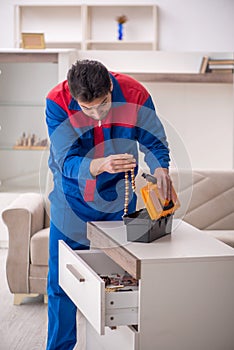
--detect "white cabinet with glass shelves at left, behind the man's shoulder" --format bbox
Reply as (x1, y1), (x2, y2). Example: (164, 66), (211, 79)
(0, 49), (77, 192)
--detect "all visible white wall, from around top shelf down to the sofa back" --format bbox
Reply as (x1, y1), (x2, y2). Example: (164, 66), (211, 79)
(0, 0), (234, 168)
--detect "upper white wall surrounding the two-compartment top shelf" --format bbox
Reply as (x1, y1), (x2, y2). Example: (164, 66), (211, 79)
(0, 0), (234, 51)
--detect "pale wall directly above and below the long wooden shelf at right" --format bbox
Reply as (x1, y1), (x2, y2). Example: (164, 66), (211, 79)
(78, 51), (234, 169)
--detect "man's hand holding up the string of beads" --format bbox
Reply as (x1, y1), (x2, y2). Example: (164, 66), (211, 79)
(90, 153), (136, 176)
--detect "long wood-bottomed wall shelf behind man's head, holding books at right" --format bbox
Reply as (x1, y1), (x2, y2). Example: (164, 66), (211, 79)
(74, 50), (234, 84)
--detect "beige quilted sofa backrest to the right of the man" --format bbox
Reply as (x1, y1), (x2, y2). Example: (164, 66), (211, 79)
(178, 170), (234, 231)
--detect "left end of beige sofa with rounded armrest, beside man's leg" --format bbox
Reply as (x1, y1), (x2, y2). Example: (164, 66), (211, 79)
(2, 193), (49, 304)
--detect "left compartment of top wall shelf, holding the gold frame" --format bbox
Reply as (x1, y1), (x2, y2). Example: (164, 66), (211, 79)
(15, 4), (83, 49)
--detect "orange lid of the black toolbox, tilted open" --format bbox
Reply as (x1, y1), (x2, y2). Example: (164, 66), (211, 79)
(140, 173), (180, 220)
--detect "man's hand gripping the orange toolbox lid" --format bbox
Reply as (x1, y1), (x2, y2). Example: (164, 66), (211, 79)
(154, 168), (172, 201)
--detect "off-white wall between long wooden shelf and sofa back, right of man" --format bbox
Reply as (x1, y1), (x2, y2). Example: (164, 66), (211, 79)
(145, 83), (234, 169)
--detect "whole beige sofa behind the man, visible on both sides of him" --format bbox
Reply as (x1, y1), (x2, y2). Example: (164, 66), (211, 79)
(2, 170), (234, 304)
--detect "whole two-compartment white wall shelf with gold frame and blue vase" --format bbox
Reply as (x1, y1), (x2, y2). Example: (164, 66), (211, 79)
(15, 3), (158, 50)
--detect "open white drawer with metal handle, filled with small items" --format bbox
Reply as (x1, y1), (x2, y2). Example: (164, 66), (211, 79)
(59, 241), (138, 335)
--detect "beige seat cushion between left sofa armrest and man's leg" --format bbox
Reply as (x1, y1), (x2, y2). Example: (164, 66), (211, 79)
(30, 227), (50, 266)
